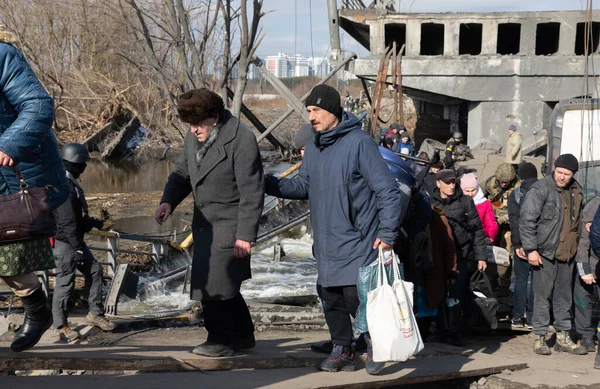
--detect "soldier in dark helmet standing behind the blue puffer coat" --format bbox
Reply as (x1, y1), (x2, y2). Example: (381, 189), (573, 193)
(52, 143), (115, 341)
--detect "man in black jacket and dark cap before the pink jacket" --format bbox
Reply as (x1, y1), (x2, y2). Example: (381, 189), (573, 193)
(431, 169), (487, 345)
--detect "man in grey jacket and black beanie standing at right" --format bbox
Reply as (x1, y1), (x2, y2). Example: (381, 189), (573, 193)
(519, 154), (587, 355)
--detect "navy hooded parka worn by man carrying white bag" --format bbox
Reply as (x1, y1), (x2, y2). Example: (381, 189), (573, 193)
(266, 112), (401, 287)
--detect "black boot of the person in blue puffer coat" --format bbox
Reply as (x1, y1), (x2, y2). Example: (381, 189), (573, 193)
(10, 286), (52, 352)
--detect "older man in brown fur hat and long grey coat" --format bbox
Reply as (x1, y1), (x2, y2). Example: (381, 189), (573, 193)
(155, 89), (264, 356)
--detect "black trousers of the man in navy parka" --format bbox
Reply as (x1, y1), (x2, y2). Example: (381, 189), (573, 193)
(321, 285), (359, 346)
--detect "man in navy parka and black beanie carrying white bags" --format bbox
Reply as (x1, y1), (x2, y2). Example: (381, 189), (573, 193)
(265, 85), (402, 374)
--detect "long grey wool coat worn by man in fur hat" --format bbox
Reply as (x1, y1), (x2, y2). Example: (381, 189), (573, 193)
(161, 110), (264, 300)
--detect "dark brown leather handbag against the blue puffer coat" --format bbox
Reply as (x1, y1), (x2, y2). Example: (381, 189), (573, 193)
(0, 165), (56, 245)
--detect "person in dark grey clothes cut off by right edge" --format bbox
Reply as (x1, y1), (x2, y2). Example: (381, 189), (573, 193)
(573, 196), (600, 352)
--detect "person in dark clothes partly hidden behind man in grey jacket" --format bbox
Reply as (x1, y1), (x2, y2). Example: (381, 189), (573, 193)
(508, 162), (538, 329)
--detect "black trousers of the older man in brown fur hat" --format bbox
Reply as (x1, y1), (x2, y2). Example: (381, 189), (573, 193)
(202, 292), (254, 346)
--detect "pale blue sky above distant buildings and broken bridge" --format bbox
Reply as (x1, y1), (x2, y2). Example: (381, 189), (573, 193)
(258, 0), (596, 57)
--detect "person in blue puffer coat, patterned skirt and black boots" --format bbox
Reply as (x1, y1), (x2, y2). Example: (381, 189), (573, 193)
(0, 26), (69, 352)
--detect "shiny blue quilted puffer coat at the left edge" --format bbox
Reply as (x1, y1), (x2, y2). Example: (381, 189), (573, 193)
(0, 42), (69, 209)
